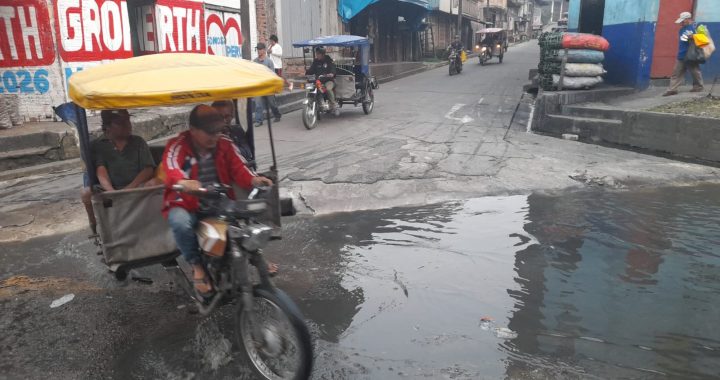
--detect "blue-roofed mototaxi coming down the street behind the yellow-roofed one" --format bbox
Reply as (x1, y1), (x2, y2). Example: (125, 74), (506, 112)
(293, 35), (379, 129)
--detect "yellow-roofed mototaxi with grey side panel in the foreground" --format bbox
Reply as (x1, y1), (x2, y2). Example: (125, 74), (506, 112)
(56, 54), (313, 379)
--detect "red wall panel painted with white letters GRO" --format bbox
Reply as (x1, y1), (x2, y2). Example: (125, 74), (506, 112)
(55, 0), (133, 62)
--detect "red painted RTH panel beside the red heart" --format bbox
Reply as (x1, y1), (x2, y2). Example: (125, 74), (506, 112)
(155, 0), (206, 53)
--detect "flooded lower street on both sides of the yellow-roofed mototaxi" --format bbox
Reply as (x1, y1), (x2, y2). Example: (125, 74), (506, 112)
(0, 186), (720, 379)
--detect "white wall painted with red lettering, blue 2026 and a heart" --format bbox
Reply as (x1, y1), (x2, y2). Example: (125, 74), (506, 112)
(0, 0), (257, 121)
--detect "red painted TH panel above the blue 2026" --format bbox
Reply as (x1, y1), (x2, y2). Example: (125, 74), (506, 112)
(0, 0), (55, 67)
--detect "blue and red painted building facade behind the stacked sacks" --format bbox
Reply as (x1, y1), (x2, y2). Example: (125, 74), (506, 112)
(568, 0), (720, 89)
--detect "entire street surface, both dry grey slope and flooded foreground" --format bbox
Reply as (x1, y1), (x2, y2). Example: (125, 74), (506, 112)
(0, 40), (720, 379)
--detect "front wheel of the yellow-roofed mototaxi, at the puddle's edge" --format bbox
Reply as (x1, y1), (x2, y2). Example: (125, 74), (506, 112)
(235, 286), (313, 380)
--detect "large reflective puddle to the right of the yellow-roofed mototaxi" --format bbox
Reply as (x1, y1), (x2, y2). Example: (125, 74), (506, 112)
(272, 187), (720, 378)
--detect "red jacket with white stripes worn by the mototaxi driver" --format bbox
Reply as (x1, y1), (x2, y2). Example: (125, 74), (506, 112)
(163, 131), (255, 217)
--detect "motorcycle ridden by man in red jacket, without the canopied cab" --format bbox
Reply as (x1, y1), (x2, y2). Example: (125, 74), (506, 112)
(172, 184), (313, 379)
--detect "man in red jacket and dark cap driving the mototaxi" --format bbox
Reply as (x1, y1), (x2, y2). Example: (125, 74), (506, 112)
(163, 105), (272, 295)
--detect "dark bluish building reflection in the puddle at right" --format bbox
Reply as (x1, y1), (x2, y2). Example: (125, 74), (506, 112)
(508, 188), (720, 378)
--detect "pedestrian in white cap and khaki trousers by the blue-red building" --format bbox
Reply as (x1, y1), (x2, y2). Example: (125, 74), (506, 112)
(663, 12), (704, 96)
